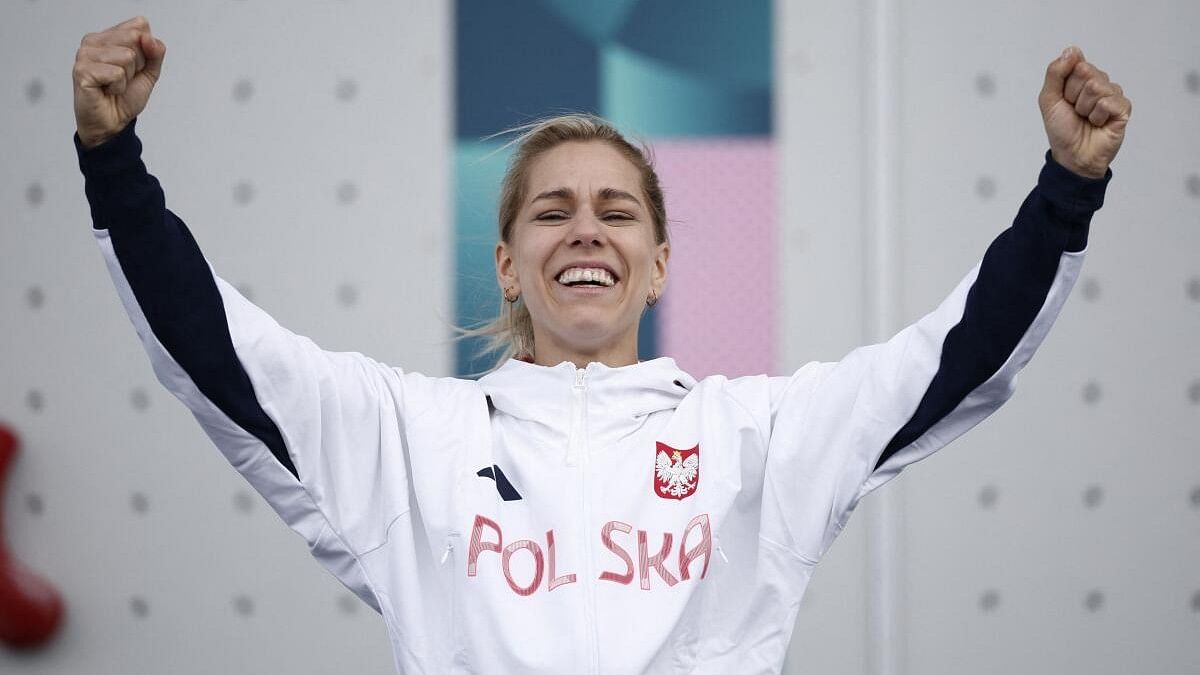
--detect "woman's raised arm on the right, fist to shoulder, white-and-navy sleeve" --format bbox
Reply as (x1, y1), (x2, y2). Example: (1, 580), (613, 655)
(763, 48), (1130, 561)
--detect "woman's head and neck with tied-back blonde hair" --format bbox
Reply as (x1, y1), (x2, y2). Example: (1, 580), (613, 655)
(460, 114), (670, 368)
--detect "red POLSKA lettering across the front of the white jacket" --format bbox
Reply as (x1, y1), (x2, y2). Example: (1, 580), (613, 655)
(467, 513), (713, 596)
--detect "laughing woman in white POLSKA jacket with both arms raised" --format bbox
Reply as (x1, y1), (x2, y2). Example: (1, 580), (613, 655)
(74, 18), (1130, 673)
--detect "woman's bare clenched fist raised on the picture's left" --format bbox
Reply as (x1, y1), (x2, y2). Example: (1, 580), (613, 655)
(72, 17), (167, 148)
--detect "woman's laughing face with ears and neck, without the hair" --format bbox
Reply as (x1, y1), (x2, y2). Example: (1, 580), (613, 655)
(496, 142), (670, 362)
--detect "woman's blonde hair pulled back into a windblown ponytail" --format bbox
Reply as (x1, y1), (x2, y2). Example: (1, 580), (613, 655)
(456, 113), (667, 370)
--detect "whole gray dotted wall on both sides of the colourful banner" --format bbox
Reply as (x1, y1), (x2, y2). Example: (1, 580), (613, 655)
(0, 0), (1200, 675)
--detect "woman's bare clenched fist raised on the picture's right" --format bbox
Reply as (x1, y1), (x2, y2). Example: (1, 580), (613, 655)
(1038, 47), (1133, 178)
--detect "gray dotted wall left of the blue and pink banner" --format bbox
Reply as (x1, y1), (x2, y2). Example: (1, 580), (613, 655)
(0, 0), (452, 675)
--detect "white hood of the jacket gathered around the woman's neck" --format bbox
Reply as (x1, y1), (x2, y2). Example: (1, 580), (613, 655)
(479, 357), (696, 432)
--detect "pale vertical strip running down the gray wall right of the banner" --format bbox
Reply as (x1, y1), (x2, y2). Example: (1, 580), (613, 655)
(863, 0), (905, 675)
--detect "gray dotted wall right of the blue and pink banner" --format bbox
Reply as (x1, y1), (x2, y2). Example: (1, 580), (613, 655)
(776, 0), (1200, 675)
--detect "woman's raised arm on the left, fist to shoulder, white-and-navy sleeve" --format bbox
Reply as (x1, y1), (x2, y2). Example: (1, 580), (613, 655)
(74, 18), (428, 610)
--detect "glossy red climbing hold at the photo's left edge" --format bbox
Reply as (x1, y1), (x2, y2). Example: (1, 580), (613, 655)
(0, 424), (62, 649)
